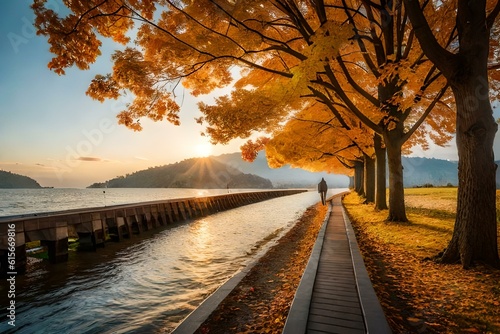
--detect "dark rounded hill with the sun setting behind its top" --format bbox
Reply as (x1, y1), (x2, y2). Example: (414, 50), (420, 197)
(89, 158), (273, 189)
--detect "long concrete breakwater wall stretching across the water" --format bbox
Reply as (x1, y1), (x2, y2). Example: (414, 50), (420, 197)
(0, 190), (305, 276)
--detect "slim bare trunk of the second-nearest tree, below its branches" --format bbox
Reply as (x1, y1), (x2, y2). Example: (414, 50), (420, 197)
(384, 130), (408, 222)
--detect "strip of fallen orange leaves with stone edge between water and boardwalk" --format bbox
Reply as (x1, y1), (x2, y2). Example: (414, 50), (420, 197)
(172, 203), (327, 334)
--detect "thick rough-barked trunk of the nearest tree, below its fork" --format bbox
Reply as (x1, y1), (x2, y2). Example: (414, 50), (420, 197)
(441, 83), (500, 268)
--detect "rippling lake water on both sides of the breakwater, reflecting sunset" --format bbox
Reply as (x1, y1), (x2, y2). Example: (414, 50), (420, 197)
(0, 189), (340, 333)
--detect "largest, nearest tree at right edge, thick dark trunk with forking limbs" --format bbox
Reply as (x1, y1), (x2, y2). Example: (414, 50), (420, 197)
(404, 0), (500, 268)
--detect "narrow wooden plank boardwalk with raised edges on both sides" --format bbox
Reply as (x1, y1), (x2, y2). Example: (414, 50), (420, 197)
(283, 195), (391, 334)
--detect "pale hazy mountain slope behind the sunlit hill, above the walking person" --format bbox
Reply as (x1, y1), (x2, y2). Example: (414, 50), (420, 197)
(214, 153), (349, 188)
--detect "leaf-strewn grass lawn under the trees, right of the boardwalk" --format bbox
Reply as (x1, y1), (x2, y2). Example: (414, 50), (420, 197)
(344, 188), (500, 333)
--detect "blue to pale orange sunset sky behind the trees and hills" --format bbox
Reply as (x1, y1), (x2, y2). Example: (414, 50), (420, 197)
(0, 0), (500, 188)
